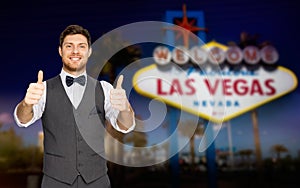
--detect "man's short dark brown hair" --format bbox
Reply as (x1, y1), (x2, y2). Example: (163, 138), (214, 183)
(59, 25), (91, 47)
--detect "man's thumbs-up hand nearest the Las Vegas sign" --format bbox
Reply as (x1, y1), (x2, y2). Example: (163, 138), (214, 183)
(110, 75), (130, 111)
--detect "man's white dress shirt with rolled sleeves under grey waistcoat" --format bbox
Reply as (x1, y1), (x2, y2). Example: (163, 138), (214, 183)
(14, 69), (135, 133)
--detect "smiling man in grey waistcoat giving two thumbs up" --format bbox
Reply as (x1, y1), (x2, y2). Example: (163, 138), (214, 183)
(15, 25), (135, 188)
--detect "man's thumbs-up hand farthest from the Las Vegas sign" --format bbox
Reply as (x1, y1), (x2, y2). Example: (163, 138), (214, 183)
(24, 70), (45, 105)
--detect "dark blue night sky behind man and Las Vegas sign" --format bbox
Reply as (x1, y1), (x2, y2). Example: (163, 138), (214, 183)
(0, 0), (300, 159)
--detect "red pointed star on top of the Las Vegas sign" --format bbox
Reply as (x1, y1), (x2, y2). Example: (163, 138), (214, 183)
(165, 4), (207, 48)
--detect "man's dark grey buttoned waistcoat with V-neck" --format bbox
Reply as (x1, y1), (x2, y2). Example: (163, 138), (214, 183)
(42, 76), (107, 184)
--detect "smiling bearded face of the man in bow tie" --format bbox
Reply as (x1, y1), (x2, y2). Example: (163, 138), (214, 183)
(59, 34), (92, 75)
